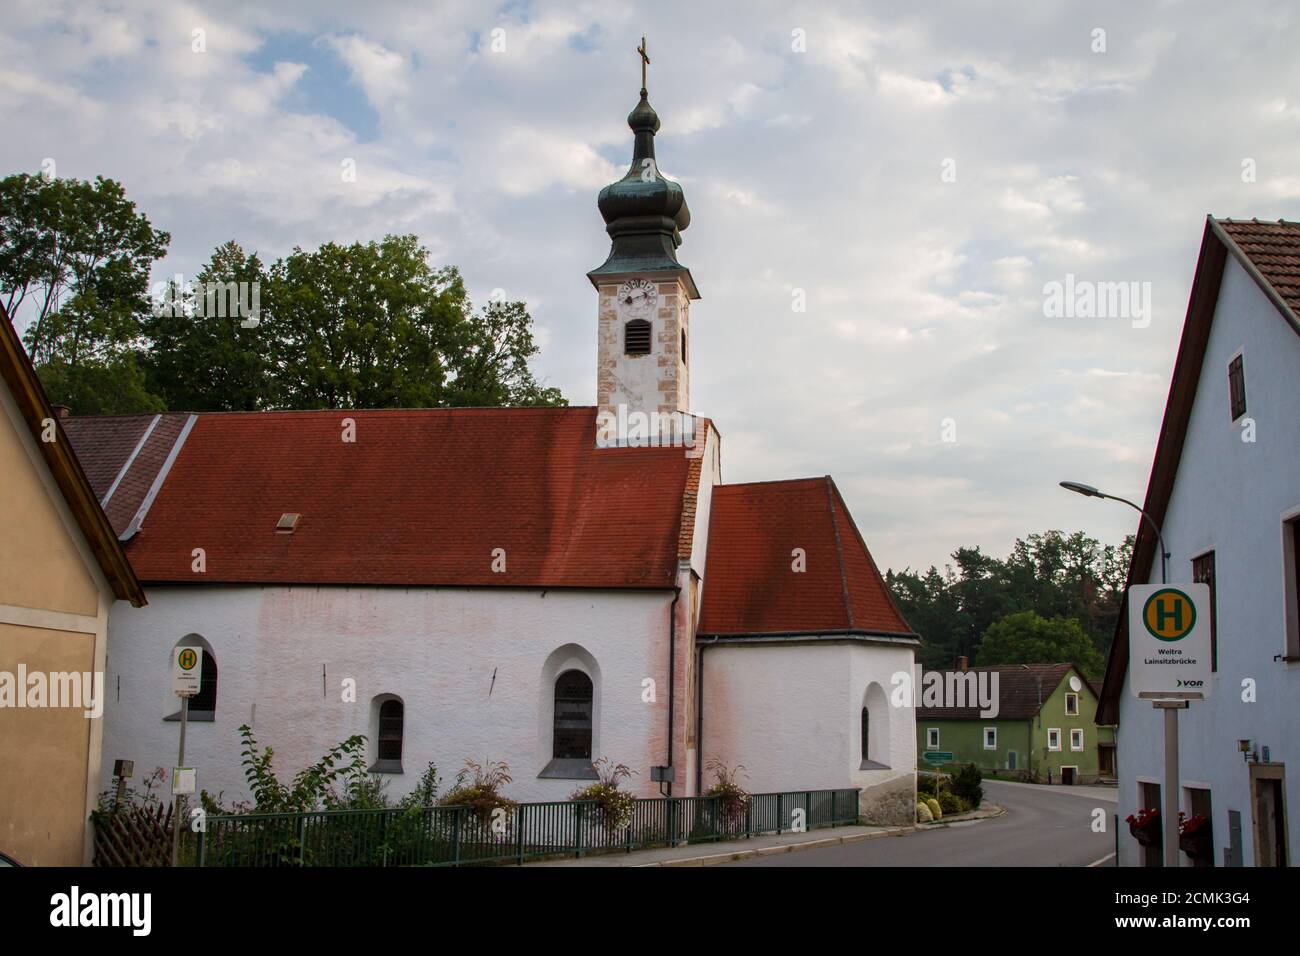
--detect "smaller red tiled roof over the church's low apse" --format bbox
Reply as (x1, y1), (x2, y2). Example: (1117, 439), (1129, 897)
(698, 477), (917, 643)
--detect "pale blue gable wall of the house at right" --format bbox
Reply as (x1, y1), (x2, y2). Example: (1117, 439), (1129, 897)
(1117, 255), (1300, 866)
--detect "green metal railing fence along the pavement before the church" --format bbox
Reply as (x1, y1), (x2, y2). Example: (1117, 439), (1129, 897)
(182, 790), (858, 866)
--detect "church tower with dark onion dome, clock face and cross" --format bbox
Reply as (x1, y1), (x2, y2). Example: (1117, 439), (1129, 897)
(586, 38), (699, 442)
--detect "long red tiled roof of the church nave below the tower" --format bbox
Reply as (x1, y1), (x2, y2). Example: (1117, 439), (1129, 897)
(65, 407), (699, 589)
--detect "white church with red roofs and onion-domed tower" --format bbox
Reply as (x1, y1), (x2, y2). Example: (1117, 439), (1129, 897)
(61, 74), (918, 823)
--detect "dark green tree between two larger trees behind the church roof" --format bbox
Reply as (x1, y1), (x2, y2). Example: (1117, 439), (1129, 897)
(146, 241), (274, 411)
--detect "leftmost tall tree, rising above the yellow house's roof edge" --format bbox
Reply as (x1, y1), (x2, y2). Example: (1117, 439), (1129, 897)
(0, 173), (170, 412)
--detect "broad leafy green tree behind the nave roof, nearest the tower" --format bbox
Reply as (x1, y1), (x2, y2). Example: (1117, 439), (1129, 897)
(264, 235), (564, 408)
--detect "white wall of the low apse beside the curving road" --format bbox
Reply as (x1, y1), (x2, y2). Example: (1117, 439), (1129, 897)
(701, 641), (917, 823)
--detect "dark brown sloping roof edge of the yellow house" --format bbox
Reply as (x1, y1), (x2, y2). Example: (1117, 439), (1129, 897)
(0, 306), (146, 607)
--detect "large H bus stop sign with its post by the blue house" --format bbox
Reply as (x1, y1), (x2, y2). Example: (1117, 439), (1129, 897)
(1128, 584), (1212, 866)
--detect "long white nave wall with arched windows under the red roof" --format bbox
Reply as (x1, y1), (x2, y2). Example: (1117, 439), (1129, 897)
(103, 587), (689, 803)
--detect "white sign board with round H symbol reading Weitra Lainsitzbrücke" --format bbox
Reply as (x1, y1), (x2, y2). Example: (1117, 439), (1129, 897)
(1128, 584), (1210, 700)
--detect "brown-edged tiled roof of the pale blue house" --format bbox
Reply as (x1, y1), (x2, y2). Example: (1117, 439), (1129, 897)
(1097, 216), (1300, 724)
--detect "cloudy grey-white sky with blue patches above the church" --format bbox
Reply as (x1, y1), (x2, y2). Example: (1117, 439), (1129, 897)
(0, 0), (1300, 567)
